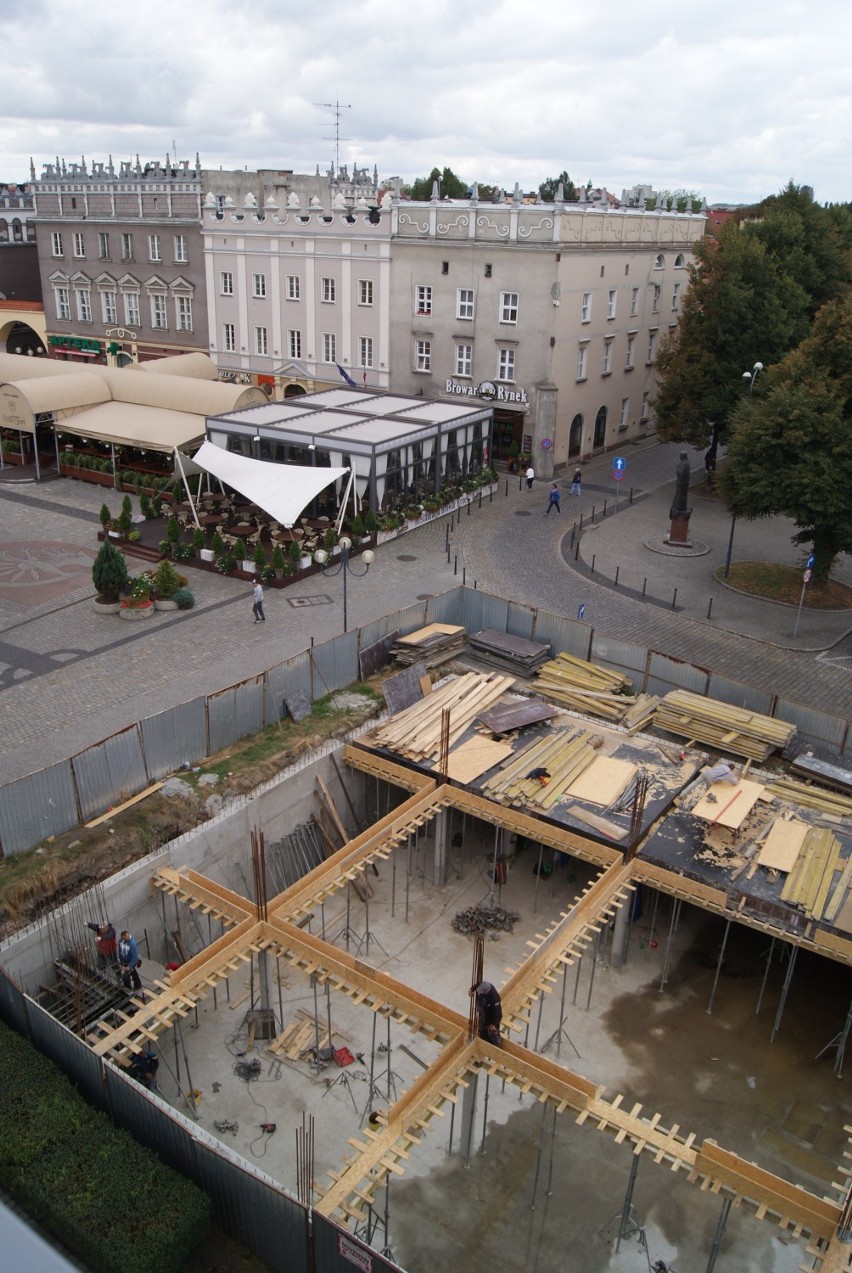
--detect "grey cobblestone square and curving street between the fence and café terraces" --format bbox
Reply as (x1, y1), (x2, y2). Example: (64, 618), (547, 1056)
(0, 444), (852, 783)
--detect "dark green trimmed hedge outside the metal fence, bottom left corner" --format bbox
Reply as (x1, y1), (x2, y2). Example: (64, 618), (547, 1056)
(0, 1023), (211, 1273)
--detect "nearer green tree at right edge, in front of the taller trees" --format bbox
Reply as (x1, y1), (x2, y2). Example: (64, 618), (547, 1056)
(722, 298), (852, 584)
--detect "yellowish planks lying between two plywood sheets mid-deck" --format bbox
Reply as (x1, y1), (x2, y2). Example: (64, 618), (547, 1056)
(483, 728), (601, 808)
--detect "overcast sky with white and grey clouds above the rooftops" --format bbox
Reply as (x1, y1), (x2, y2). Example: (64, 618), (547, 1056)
(0, 0), (852, 202)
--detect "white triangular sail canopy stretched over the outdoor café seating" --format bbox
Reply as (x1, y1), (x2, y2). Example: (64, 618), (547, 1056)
(192, 442), (349, 526)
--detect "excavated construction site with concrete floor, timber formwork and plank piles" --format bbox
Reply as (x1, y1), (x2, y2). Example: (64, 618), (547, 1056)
(3, 624), (852, 1273)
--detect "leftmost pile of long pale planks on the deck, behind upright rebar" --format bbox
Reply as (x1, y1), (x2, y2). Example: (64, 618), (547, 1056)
(368, 672), (512, 763)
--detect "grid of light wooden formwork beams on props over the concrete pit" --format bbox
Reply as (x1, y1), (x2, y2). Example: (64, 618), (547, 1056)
(89, 747), (852, 1269)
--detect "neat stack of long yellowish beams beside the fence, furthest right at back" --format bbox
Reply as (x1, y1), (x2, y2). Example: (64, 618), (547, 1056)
(653, 690), (796, 760)
